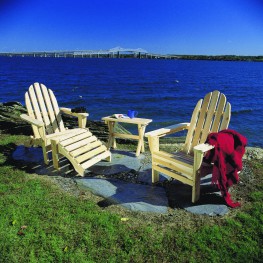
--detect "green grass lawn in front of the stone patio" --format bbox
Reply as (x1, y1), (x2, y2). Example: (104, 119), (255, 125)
(0, 135), (263, 263)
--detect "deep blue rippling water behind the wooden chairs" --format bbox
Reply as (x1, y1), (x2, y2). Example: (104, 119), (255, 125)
(0, 57), (263, 147)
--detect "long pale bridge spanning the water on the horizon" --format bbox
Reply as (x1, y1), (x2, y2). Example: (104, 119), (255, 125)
(0, 47), (178, 59)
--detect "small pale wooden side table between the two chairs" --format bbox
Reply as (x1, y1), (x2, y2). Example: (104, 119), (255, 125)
(102, 116), (152, 156)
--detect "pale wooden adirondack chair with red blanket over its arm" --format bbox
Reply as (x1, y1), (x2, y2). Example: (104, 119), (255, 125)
(145, 91), (231, 203)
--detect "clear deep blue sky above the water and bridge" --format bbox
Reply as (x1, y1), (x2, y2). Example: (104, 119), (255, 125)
(0, 0), (263, 55)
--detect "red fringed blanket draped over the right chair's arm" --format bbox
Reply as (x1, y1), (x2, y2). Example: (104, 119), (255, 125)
(204, 129), (247, 207)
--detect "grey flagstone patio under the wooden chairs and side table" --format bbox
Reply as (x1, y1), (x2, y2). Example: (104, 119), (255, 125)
(12, 146), (229, 216)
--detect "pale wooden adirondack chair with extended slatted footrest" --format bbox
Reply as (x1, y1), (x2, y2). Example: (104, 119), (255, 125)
(20, 83), (111, 176)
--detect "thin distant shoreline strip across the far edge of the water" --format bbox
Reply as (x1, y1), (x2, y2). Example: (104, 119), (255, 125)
(0, 52), (263, 62)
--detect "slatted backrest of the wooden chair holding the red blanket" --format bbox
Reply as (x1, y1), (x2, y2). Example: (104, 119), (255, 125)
(183, 91), (231, 154)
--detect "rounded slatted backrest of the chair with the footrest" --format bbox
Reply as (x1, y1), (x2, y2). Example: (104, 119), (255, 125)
(25, 83), (65, 138)
